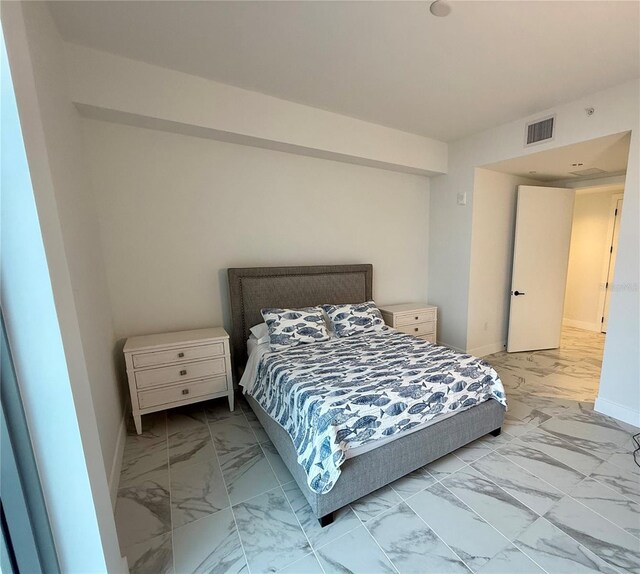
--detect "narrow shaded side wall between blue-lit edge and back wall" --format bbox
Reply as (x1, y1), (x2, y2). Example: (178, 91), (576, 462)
(6, 6), (123, 500)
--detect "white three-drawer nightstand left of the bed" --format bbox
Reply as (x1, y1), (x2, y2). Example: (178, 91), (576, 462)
(123, 327), (233, 434)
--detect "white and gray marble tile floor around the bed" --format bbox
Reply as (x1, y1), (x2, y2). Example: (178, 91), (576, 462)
(116, 329), (640, 574)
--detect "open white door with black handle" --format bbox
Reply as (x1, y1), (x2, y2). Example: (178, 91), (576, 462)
(507, 185), (575, 353)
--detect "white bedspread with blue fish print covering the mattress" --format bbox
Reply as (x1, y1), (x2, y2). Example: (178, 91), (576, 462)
(251, 329), (506, 494)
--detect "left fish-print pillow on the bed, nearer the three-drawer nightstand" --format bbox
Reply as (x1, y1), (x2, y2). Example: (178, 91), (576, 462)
(260, 307), (329, 351)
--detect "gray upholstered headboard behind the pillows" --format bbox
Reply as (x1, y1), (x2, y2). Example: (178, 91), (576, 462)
(228, 264), (373, 382)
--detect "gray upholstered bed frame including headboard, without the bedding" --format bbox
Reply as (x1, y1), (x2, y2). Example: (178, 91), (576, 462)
(228, 265), (505, 526)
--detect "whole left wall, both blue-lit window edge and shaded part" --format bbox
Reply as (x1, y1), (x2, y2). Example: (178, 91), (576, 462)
(2, 2), (123, 573)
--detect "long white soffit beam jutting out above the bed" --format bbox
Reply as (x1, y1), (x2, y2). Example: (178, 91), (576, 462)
(67, 44), (447, 175)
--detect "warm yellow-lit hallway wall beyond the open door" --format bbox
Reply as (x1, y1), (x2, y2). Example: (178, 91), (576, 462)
(563, 189), (622, 333)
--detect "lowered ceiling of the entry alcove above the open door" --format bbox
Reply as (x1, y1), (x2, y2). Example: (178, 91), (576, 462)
(483, 132), (631, 181)
